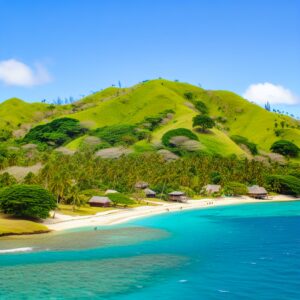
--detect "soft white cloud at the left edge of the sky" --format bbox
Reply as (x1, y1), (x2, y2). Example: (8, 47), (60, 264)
(0, 59), (51, 87)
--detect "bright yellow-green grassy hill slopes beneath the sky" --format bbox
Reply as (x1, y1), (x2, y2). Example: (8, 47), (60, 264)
(0, 79), (300, 156)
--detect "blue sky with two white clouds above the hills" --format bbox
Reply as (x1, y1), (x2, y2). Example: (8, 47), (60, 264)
(0, 0), (300, 116)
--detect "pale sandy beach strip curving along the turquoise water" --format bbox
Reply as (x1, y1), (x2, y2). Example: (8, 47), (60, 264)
(44, 195), (297, 231)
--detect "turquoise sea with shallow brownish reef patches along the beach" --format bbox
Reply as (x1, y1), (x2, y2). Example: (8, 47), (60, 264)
(0, 201), (300, 300)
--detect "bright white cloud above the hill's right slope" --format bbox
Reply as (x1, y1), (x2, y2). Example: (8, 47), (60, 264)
(243, 82), (300, 105)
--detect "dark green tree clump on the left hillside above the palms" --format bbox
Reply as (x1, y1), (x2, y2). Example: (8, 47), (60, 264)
(23, 118), (86, 147)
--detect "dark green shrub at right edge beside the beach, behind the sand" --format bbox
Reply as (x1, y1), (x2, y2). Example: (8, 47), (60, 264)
(267, 175), (300, 196)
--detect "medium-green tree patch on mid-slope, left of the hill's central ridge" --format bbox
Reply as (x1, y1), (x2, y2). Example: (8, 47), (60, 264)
(93, 125), (147, 146)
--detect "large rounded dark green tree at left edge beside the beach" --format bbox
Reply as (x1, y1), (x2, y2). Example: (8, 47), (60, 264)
(0, 184), (56, 218)
